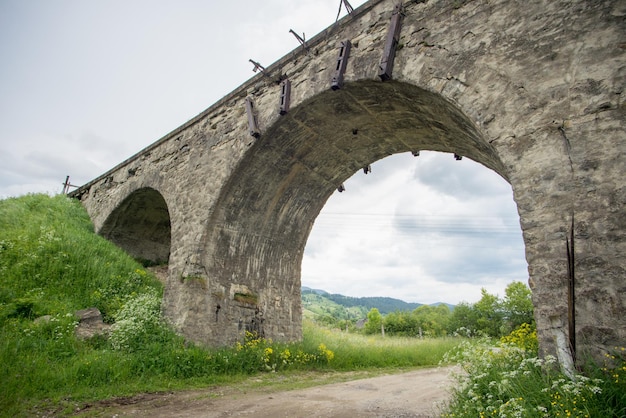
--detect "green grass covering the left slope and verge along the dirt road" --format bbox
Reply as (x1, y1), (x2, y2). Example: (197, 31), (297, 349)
(0, 195), (459, 417)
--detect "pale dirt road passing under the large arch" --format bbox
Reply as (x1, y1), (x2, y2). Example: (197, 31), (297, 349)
(79, 368), (452, 418)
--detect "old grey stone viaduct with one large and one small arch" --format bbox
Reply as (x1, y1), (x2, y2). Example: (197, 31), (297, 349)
(71, 0), (626, 363)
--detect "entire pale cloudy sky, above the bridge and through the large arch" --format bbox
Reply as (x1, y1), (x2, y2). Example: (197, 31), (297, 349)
(0, 0), (527, 303)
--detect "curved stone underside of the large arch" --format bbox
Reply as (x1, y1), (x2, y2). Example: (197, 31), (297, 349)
(203, 80), (520, 340)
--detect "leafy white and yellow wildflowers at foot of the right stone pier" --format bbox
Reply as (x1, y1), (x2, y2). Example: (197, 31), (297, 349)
(442, 332), (626, 418)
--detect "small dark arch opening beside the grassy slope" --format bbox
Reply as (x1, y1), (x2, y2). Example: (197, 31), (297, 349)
(98, 187), (171, 265)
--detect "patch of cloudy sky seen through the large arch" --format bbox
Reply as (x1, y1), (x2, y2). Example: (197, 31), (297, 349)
(302, 151), (528, 305)
